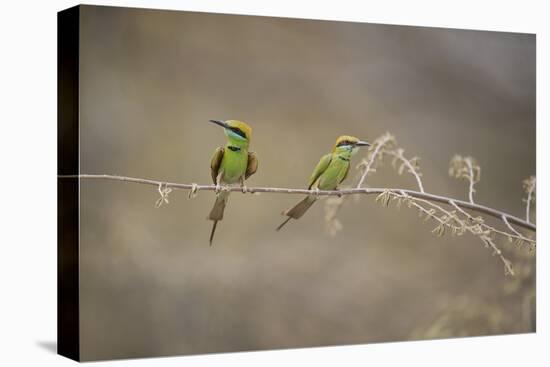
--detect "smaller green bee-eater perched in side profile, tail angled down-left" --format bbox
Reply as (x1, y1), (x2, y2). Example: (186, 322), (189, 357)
(277, 135), (370, 231)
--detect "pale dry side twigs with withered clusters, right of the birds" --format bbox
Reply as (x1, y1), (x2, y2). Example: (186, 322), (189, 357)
(325, 133), (536, 275)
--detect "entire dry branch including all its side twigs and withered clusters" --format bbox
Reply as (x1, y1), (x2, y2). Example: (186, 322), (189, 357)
(60, 133), (536, 275)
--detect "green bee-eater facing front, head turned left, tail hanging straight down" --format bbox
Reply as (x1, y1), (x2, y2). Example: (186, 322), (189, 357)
(208, 120), (258, 246)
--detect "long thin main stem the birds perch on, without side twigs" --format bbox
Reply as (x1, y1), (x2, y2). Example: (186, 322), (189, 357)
(58, 174), (537, 231)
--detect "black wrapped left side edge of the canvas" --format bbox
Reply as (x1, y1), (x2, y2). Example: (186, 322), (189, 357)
(57, 6), (80, 360)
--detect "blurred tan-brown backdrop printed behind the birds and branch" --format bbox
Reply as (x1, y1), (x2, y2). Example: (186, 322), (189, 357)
(76, 6), (535, 359)
